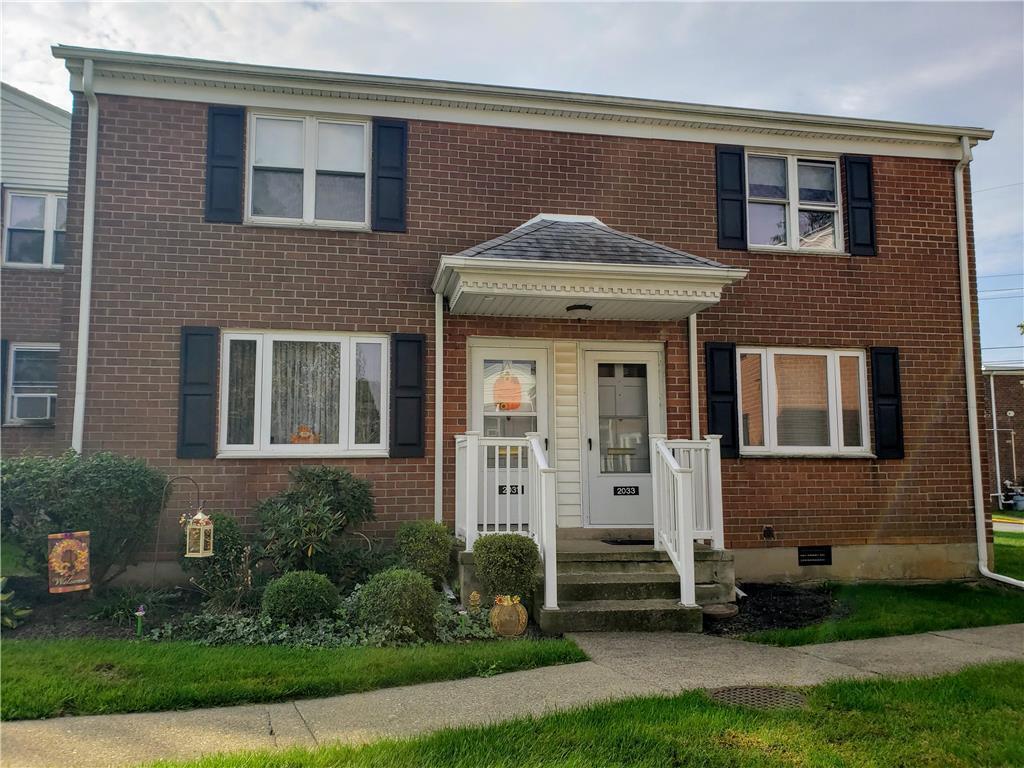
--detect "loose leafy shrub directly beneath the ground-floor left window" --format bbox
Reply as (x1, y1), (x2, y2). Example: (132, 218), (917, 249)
(256, 466), (374, 573)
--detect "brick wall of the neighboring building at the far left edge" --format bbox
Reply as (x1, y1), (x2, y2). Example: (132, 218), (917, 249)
(0, 186), (66, 457)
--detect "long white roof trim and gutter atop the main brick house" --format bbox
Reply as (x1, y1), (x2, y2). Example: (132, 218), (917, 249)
(53, 45), (992, 159)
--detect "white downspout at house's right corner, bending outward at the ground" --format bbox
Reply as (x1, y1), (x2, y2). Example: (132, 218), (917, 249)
(953, 136), (1024, 589)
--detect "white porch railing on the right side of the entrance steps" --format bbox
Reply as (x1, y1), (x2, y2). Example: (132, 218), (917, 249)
(650, 435), (725, 605)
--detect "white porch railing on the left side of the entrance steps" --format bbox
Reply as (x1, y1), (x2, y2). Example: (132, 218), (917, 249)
(455, 432), (558, 609)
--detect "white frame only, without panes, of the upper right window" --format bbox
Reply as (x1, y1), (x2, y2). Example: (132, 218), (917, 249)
(743, 150), (846, 254)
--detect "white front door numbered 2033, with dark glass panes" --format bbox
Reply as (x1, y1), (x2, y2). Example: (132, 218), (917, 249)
(583, 350), (663, 527)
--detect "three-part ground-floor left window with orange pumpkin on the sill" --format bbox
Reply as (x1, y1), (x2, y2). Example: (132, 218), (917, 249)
(219, 332), (387, 457)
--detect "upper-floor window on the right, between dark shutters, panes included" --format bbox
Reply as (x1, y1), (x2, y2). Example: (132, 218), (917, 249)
(746, 153), (843, 251)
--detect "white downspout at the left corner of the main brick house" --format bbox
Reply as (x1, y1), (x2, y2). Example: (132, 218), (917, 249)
(71, 58), (99, 454)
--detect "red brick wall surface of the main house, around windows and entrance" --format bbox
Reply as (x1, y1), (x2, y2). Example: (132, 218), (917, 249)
(58, 96), (983, 553)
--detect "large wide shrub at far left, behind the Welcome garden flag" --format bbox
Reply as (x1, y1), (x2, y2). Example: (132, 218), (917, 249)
(0, 451), (167, 586)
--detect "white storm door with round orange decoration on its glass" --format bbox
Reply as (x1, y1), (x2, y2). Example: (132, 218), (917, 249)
(470, 347), (548, 531)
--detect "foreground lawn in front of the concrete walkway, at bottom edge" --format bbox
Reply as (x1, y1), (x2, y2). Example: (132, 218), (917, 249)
(146, 664), (1024, 768)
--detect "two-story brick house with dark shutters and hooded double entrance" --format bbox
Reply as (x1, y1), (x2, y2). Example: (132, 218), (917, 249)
(34, 47), (1007, 624)
